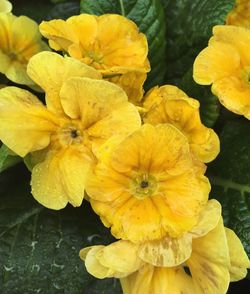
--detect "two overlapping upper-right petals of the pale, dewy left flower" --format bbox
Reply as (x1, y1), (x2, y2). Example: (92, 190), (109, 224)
(60, 78), (141, 140)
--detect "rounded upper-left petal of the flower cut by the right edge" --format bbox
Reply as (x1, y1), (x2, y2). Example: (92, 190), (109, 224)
(193, 40), (241, 85)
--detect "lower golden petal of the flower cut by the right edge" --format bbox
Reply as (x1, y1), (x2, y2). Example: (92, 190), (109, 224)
(212, 76), (250, 118)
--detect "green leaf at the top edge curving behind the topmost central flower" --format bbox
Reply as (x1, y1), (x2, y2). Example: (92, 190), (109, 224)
(81, 0), (166, 89)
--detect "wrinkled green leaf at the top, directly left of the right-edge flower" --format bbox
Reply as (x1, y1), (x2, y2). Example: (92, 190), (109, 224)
(162, 0), (235, 82)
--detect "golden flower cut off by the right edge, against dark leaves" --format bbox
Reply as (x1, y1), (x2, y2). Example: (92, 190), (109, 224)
(194, 26), (250, 119)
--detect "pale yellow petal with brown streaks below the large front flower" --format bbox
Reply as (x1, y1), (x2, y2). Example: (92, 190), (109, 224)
(138, 234), (192, 267)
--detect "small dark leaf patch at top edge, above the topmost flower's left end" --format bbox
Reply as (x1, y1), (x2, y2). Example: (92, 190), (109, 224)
(46, 1), (80, 20)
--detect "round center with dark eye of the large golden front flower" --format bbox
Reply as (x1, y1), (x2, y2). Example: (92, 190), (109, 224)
(130, 173), (158, 200)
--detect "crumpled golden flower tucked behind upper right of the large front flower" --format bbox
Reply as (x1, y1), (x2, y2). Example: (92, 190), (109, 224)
(143, 85), (220, 162)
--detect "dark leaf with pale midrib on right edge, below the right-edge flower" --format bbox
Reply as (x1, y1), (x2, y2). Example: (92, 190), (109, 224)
(208, 120), (250, 256)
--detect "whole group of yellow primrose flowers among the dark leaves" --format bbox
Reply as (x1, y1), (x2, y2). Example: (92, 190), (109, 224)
(0, 0), (250, 294)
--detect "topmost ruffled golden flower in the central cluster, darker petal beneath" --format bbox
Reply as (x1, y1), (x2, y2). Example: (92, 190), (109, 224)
(40, 14), (150, 101)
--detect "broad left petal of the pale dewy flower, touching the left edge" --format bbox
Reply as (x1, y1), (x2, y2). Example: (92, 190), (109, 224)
(0, 87), (57, 157)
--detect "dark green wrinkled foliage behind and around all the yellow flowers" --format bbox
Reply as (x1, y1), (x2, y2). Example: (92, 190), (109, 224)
(0, 0), (250, 294)
